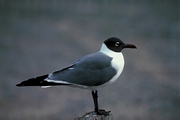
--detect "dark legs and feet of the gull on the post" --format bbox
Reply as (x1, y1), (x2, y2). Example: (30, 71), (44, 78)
(91, 90), (110, 115)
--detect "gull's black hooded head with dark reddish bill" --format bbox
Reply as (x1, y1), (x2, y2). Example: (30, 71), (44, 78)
(104, 37), (137, 52)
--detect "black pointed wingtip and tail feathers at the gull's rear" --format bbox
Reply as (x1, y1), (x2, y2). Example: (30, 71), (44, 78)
(16, 74), (65, 87)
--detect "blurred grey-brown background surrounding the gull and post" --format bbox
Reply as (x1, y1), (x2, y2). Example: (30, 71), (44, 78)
(0, 0), (180, 120)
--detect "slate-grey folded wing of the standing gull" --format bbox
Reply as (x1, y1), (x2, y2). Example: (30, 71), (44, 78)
(48, 52), (116, 86)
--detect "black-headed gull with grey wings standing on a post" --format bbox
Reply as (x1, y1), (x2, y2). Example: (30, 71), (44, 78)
(16, 37), (137, 115)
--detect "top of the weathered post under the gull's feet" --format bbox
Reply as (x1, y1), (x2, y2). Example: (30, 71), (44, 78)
(74, 111), (113, 120)
